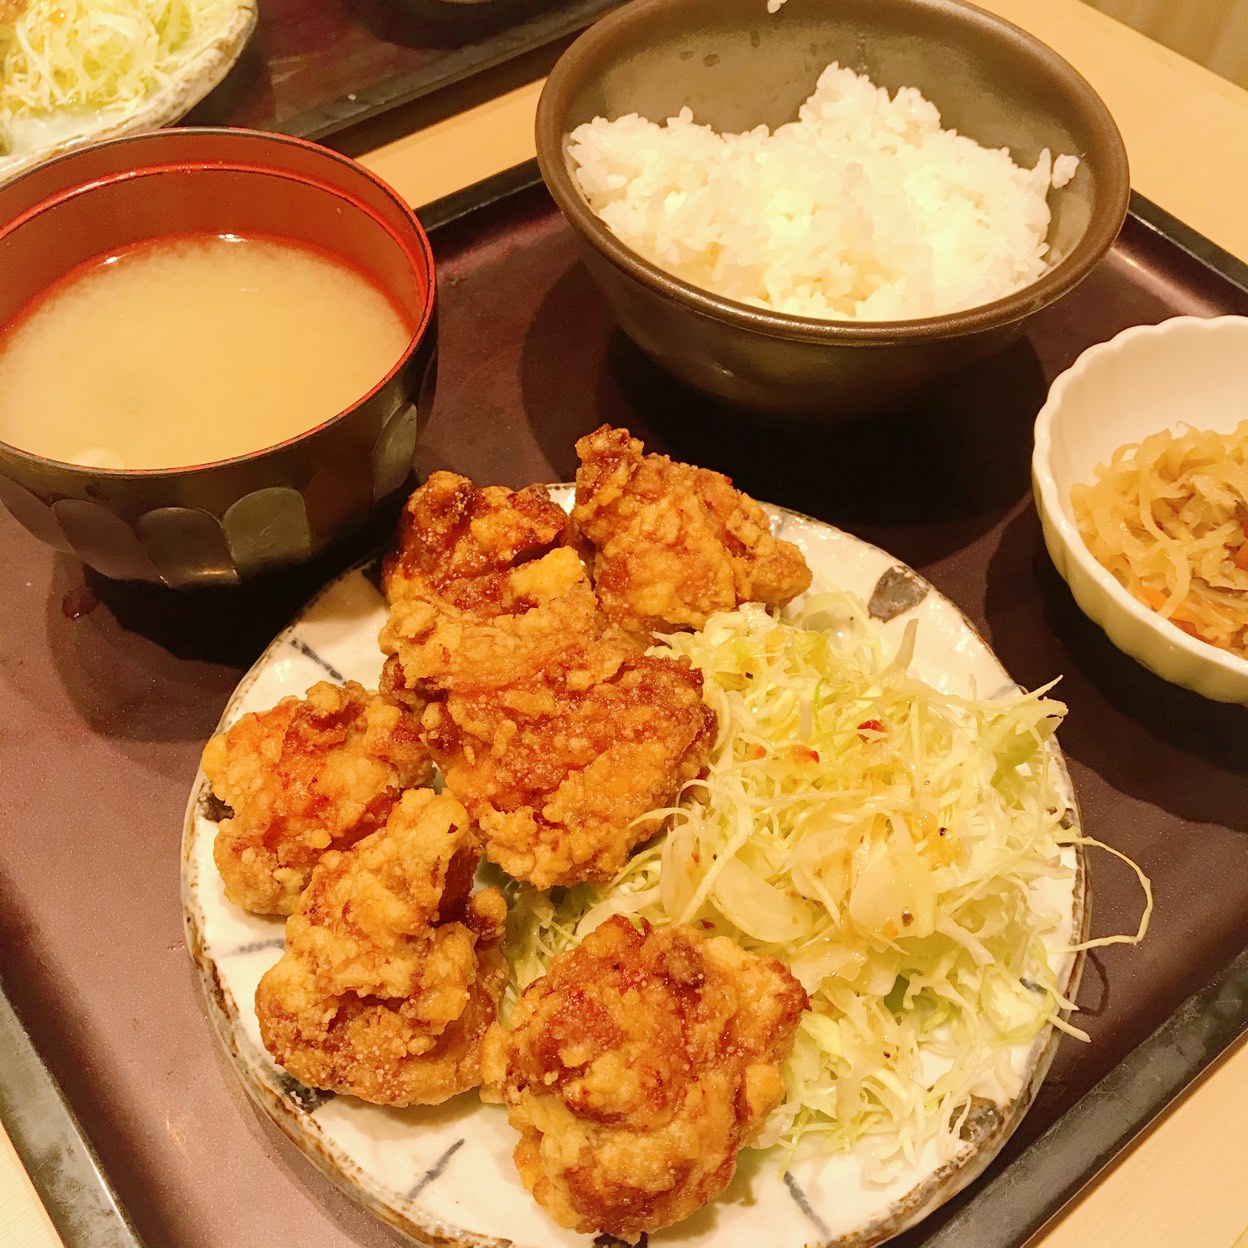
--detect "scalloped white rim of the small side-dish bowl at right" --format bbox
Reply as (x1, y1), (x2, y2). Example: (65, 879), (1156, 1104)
(1031, 314), (1248, 683)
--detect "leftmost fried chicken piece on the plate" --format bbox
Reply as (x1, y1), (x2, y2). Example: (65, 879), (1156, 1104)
(203, 680), (433, 915)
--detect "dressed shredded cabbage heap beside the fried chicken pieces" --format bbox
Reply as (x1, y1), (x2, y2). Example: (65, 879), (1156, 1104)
(504, 593), (1152, 1181)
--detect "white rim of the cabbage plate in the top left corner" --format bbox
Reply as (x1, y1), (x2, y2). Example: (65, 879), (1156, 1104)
(0, 0), (258, 185)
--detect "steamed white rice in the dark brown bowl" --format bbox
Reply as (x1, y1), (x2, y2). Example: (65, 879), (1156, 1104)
(570, 65), (1078, 321)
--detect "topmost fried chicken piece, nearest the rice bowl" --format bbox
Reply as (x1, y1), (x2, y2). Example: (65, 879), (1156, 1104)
(572, 424), (810, 631)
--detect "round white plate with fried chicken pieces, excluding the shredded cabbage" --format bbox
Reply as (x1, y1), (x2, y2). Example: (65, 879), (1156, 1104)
(182, 427), (1087, 1248)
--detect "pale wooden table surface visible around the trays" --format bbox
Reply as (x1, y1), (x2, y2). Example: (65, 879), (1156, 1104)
(0, 0), (1248, 1248)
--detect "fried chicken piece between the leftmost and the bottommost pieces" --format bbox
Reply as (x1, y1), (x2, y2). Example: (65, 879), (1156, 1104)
(256, 789), (507, 1106)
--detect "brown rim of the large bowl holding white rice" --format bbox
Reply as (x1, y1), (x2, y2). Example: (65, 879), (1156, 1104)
(534, 0), (1131, 347)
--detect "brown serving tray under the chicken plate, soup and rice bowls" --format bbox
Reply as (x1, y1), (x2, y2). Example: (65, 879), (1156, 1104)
(0, 166), (1248, 1248)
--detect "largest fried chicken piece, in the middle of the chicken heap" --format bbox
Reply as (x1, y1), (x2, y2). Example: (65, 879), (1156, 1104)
(381, 548), (716, 889)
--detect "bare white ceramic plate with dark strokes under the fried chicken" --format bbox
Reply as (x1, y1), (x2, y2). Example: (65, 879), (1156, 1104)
(182, 487), (1087, 1248)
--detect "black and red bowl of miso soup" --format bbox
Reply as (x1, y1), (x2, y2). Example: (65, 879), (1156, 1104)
(0, 129), (437, 587)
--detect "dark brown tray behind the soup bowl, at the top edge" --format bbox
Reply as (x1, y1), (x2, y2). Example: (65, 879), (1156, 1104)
(186, 0), (624, 139)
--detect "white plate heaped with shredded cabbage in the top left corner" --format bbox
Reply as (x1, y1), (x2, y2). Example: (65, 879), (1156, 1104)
(0, 0), (257, 183)
